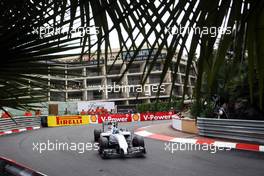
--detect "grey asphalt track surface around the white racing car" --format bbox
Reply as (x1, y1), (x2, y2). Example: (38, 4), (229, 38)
(0, 121), (264, 176)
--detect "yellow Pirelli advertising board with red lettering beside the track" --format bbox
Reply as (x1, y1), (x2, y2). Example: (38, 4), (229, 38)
(48, 115), (90, 127)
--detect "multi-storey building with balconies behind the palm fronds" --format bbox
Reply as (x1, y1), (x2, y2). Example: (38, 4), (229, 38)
(48, 49), (196, 105)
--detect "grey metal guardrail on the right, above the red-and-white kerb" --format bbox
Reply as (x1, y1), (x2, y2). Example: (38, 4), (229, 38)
(197, 118), (264, 144)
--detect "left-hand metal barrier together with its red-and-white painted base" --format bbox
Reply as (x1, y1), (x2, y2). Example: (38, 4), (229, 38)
(0, 116), (41, 135)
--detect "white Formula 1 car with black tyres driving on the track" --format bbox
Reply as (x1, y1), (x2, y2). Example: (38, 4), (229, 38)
(94, 122), (146, 158)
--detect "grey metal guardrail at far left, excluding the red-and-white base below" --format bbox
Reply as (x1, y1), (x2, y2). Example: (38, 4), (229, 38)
(0, 116), (41, 131)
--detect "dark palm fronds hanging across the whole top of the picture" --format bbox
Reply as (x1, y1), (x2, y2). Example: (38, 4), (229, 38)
(0, 0), (264, 114)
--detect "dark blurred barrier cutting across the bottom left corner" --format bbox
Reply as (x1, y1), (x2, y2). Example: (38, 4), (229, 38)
(0, 157), (45, 176)
